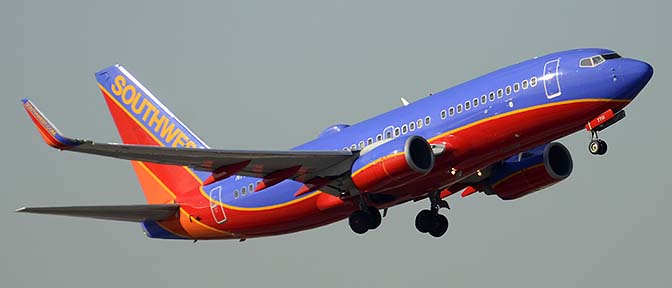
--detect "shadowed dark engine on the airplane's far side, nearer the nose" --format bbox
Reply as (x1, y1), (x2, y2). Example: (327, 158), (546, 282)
(481, 143), (574, 200)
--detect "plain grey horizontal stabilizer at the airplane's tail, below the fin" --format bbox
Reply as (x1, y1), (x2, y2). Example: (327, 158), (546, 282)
(16, 204), (180, 222)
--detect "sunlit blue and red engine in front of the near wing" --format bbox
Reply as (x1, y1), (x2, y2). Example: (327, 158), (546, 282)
(351, 136), (434, 192)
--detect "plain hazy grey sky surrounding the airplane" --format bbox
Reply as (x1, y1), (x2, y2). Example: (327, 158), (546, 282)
(0, 0), (672, 287)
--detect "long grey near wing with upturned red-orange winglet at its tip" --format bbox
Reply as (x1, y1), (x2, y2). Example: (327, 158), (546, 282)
(23, 99), (358, 192)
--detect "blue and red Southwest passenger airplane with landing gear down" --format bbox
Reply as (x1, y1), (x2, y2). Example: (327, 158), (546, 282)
(17, 48), (653, 241)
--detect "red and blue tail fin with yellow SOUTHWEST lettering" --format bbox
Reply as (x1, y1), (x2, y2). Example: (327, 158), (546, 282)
(96, 65), (208, 204)
